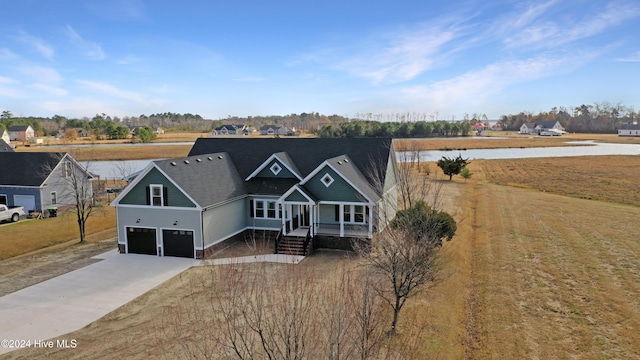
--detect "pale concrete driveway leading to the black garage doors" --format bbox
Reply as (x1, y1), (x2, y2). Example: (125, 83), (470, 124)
(0, 250), (201, 354)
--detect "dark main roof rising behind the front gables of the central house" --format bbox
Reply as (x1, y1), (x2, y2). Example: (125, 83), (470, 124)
(189, 138), (395, 195)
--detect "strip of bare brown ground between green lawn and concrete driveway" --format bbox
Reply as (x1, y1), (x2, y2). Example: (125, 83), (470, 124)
(0, 239), (116, 296)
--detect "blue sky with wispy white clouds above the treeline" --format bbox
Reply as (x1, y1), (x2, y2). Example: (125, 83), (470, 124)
(0, 0), (640, 119)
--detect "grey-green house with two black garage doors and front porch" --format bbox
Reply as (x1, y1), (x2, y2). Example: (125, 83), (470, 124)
(111, 138), (397, 258)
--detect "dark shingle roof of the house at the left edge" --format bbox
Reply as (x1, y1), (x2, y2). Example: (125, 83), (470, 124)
(0, 152), (67, 186)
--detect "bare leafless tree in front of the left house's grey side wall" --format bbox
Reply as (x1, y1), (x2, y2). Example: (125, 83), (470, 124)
(43, 153), (96, 242)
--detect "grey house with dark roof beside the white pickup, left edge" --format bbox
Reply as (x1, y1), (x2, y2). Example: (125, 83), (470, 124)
(0, 152), (93, 212)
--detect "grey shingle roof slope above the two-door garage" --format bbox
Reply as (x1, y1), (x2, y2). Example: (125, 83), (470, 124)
(153, 153), (246, 207)
